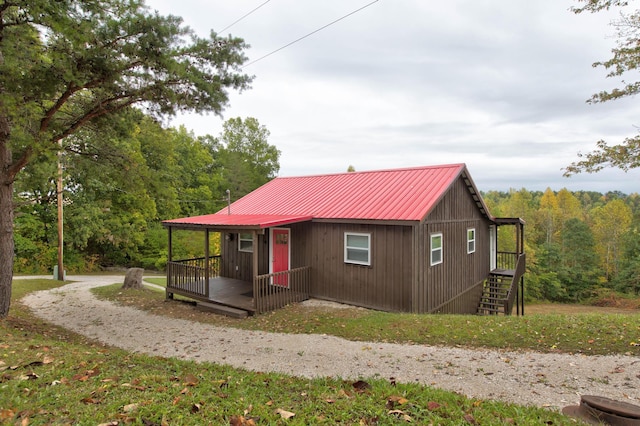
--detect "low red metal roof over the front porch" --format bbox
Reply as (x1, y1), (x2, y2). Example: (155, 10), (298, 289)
(162, 213), (313, 232)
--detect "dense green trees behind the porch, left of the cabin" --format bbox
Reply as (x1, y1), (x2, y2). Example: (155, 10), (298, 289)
(14, 109), (280, 273)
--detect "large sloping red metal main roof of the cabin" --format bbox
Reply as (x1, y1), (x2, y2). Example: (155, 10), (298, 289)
(216, 164), (466, 221)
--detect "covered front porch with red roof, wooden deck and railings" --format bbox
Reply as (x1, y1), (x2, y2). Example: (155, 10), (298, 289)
(163, 215), (311, 315)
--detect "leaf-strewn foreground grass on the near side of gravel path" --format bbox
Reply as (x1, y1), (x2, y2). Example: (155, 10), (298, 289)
(0, 280), (592, 425)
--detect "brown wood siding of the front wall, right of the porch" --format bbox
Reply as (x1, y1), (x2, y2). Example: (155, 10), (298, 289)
(301, 222), (413, 311)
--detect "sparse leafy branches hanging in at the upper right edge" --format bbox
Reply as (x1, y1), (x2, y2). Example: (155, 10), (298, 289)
(564, 0), (640, 176)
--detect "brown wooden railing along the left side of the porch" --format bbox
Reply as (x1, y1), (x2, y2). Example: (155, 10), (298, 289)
(167, 256), (221, 298)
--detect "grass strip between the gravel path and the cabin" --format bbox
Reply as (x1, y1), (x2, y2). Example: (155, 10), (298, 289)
(94, 286), (640, 355)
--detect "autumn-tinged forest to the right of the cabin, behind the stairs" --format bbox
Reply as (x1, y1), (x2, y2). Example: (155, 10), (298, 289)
(483, 188), (640, 302)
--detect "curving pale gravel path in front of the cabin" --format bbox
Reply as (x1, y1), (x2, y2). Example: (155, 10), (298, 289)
(20, 276), (640, 408)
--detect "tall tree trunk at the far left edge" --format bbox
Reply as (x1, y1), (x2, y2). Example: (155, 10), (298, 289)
(0, 125), (14, 318)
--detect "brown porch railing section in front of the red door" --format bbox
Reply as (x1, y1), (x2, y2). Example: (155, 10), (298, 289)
(253, 266), (311, 314)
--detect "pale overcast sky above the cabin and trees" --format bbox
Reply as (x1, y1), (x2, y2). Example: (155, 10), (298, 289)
(147, 0), (640, 193)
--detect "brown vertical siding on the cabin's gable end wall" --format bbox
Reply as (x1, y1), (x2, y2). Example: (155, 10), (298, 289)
(413, 179), (491, 313)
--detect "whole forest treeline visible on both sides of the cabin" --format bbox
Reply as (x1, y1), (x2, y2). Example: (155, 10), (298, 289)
(14, 109), (640, 302)
